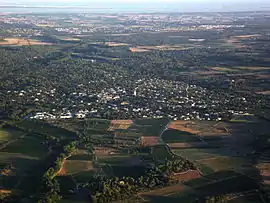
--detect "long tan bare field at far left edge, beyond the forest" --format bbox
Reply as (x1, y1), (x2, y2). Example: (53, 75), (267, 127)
(0, 38), (51, 46)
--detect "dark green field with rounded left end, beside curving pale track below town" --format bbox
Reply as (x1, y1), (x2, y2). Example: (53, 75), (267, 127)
(162, 130), (200, 143)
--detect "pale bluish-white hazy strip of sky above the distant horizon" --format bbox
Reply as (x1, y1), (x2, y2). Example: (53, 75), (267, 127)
(0, 0), (270, 12)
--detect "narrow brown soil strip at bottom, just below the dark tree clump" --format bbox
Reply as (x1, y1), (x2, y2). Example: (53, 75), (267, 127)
(139, 184), (185, 196)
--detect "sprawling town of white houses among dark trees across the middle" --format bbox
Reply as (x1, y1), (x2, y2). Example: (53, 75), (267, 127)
(7, 78), (252, 121)
